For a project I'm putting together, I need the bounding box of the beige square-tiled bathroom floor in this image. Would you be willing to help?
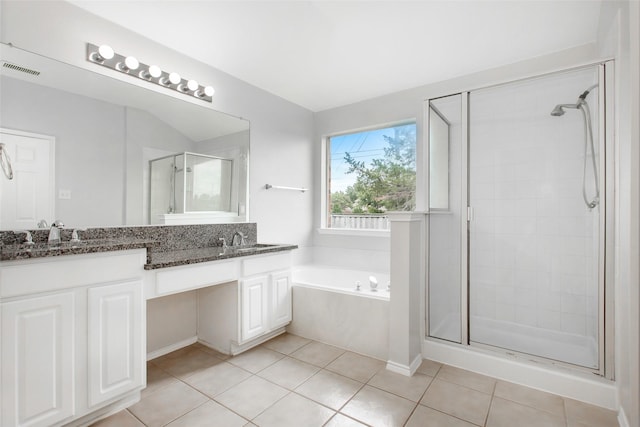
[94,334,618,427]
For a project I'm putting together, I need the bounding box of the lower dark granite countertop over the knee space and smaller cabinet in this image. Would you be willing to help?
[144,243,298,270]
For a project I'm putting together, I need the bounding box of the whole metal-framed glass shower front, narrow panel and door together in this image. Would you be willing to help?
[427,64,611,374]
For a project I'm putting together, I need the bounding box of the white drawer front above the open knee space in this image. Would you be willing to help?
[156,261,238,295]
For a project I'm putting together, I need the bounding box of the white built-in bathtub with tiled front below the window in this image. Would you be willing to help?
[287,265,391,361]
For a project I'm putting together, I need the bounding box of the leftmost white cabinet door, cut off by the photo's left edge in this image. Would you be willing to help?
[0,292,76,427]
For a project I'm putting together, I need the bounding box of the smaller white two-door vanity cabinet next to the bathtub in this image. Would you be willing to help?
[198,252,291,354]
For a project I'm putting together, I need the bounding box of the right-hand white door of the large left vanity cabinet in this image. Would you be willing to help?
[88,281,145,407]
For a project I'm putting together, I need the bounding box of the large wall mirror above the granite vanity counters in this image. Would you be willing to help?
[0,44,249,230]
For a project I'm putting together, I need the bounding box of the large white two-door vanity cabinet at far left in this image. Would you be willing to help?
[0,249,146,427]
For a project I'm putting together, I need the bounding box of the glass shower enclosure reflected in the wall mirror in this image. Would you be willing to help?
[149,152,233,224]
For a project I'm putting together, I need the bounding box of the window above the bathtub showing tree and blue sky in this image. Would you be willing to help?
[325,123,416,230]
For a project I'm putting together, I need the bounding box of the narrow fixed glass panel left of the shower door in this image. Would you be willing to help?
[428,94,467,343]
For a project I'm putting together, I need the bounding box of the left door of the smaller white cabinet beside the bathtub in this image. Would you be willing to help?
[240,276,269,342]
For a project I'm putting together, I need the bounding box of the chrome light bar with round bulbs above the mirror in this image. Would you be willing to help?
[87,43,214,102]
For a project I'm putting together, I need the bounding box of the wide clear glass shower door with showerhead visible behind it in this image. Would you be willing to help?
[468,66,605,370]
